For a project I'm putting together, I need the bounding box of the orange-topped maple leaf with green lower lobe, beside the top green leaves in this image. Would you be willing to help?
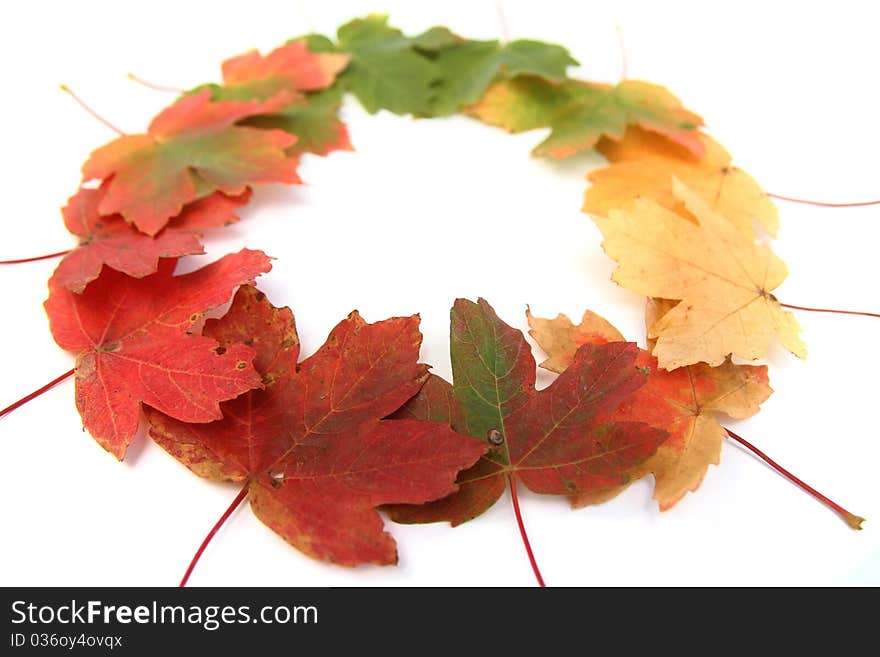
[197,39,352,155]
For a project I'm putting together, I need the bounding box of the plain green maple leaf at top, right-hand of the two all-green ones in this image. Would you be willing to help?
[431,39,578,116]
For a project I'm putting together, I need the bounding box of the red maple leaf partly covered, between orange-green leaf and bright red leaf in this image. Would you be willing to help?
[54,183,250,294]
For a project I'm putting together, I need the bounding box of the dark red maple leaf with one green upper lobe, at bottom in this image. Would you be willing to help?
[390,299,667,525]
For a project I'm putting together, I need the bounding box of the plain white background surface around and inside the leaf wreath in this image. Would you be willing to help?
[0,0,880,586]
